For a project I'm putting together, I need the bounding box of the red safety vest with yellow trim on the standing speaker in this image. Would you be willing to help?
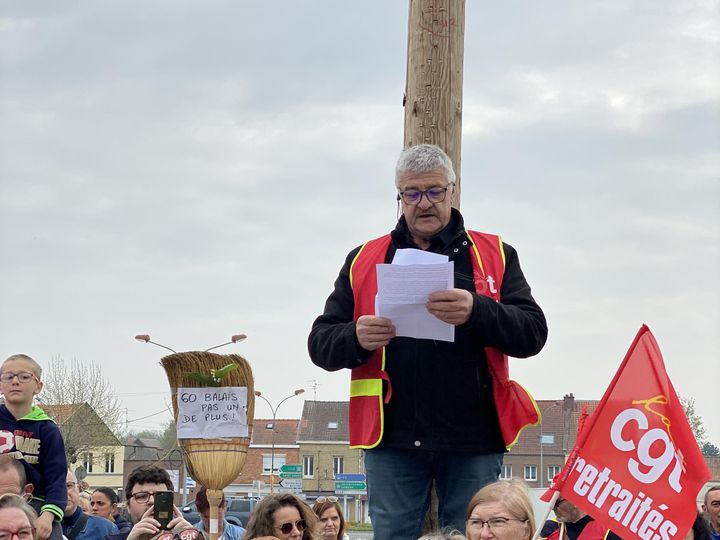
[349,231,540,450]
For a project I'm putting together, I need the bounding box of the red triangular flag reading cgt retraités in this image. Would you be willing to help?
[552,325,710,540]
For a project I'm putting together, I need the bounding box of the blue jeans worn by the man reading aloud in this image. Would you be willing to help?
[365,448,503,540]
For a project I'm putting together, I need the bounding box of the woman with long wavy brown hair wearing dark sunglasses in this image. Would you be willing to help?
[243,493,317,540]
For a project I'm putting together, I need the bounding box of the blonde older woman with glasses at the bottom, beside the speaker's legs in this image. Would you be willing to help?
[465,480,535,540]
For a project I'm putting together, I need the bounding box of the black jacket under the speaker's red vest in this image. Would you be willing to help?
[308,210,547,454]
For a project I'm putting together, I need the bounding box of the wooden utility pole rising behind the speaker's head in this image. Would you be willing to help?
[403,0,465,208]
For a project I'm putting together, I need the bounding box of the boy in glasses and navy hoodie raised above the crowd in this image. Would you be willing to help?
[0,354,67,540]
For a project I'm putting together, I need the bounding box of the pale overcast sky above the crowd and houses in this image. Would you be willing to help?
[0,0,720,445]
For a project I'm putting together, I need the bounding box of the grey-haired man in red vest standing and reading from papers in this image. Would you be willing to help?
[308,144,547,540]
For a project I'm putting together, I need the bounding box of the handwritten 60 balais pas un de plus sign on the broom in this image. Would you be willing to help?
[177,386,248,439]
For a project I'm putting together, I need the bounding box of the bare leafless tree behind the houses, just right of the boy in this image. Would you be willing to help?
[39,357,124,442]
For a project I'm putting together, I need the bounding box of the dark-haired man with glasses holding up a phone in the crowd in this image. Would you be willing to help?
[105,465,193,540]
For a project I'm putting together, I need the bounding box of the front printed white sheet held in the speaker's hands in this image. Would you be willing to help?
[375,260,455,341]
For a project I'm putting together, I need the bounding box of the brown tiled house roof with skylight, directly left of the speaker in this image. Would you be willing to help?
[298,401,349,442]
